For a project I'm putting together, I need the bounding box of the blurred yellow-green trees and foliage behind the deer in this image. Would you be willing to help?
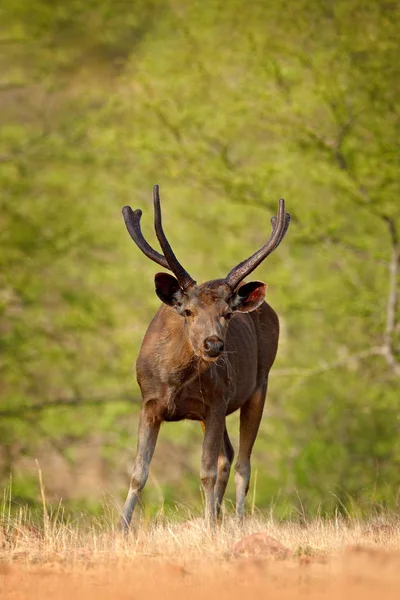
[0,0,400,517]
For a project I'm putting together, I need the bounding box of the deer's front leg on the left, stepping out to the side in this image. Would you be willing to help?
[118,405,161,533]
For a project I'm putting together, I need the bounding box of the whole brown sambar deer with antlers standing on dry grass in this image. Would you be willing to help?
[119,185,290,532]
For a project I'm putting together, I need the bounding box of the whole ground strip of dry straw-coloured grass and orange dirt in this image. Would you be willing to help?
[0,504,400,600]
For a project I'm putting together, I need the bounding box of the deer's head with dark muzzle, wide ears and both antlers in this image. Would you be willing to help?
[122,185,290,361]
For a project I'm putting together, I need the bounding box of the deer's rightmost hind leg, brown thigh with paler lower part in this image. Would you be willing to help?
[235,382,267,520]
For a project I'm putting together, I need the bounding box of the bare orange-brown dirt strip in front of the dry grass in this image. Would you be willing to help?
[0,547,400,600]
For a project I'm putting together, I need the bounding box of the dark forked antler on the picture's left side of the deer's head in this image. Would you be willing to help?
[122,185,196,291]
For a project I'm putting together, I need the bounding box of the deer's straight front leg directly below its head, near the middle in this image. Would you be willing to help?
[200,409,225,530]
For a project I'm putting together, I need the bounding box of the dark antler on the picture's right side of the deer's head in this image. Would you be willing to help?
[225,198,290,290]
